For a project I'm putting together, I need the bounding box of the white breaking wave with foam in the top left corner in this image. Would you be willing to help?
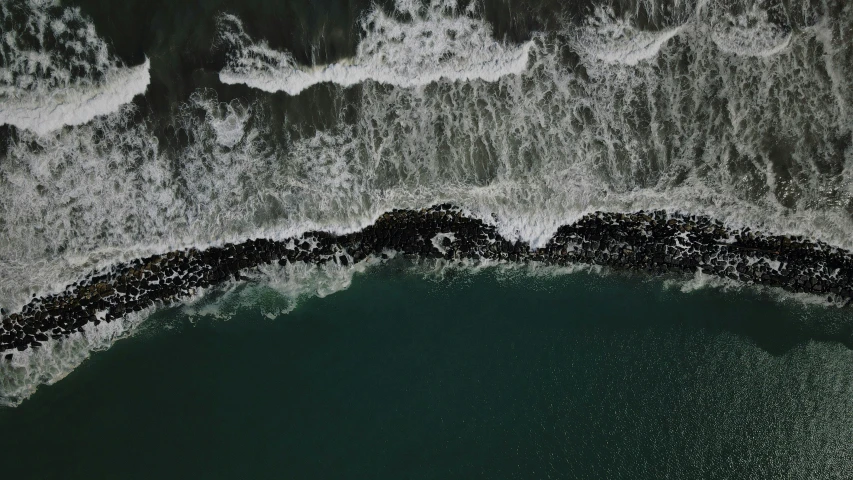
[0,0,150,135]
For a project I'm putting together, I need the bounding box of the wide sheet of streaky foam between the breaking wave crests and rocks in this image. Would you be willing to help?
[0,0,853,309]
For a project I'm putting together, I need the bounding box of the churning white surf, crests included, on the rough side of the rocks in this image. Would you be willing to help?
[0,0,853,404]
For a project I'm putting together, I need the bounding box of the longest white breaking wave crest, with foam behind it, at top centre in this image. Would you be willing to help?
[219,0,532,95]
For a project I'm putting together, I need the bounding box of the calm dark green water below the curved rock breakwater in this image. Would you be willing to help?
[0,266,853,479]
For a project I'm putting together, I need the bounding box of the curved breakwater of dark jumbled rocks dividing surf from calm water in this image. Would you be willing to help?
[0,204,853,360]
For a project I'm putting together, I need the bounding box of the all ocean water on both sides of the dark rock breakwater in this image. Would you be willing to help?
[0,0,853,472]
